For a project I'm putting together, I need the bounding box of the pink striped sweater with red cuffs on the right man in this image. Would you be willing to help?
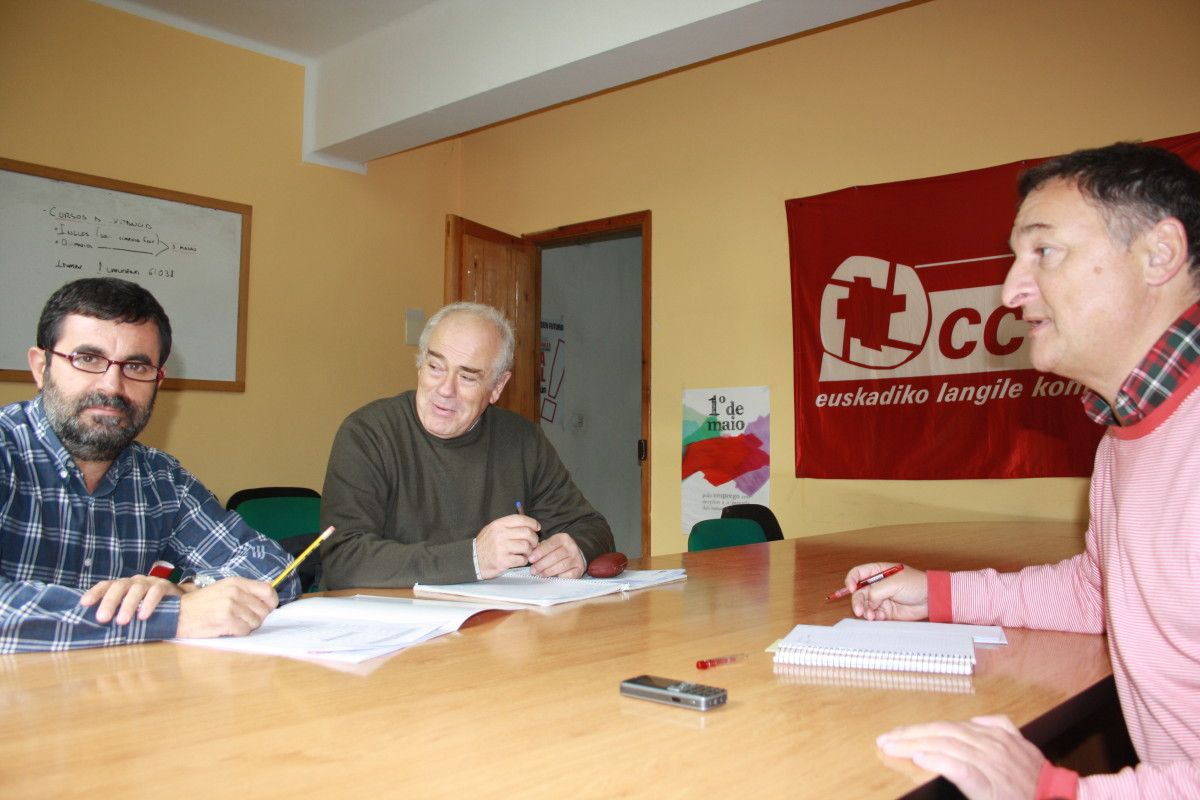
[930,369,1200,799]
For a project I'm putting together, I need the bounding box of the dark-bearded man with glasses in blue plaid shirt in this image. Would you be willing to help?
[0,278,299,652]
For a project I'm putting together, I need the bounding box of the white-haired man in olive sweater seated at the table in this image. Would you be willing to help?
[322,302,613,589]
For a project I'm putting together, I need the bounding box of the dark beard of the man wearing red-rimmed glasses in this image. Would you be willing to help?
[42,381,158,462]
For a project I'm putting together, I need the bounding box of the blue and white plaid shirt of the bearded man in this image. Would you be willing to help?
[0,396,300,652]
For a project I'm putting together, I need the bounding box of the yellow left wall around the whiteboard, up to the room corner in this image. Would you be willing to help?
[0,0,458,500]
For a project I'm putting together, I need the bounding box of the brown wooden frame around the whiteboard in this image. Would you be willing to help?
[0,157,251,392]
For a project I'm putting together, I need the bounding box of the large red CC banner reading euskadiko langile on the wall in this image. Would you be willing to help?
[785,134,1200,480]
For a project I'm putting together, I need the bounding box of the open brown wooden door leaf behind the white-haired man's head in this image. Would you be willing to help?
[444,213,541,422]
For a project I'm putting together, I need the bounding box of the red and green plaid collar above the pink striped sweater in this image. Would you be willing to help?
[1084,303,1200,427]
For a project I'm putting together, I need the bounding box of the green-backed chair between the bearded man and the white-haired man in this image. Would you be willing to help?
[226,486,320,591]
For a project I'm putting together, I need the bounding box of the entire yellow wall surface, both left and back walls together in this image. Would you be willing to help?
[0,0,1200,553]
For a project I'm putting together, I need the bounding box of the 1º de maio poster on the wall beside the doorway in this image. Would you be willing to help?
[683,386,770,534]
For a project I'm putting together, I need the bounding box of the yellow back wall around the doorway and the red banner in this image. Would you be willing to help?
[446,0,1200,553]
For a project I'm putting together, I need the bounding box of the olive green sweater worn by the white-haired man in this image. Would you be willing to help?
[320,391,613,589]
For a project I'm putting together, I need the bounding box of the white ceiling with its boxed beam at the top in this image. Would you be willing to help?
[94,0,901,172]
